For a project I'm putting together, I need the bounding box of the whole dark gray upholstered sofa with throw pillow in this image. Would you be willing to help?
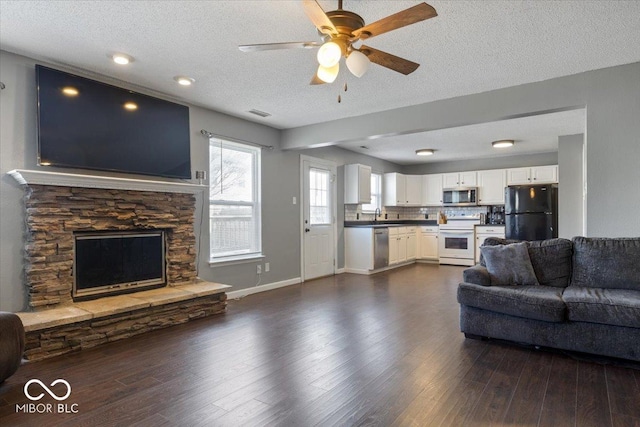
[458,237,640,361]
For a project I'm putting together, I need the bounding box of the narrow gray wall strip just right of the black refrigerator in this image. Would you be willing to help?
[558,134,584,239]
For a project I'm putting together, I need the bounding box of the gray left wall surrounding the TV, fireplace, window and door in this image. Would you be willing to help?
[0,51,399,311]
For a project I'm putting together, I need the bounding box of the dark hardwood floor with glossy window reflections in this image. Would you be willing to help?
[0,265,640,427]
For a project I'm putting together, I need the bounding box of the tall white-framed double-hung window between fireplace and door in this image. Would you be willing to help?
[209,138,262,261]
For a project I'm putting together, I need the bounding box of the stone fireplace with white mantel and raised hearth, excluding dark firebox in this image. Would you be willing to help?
[9,170,229,359]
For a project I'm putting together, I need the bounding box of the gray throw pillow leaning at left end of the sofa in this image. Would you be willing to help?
[480,242,539,285]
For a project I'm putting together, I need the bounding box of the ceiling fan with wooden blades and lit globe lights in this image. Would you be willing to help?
[238,0,438,84]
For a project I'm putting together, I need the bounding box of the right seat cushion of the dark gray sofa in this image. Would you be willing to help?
[562,286,640,328]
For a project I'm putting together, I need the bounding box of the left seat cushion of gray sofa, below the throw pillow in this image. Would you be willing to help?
[458,283,566,322]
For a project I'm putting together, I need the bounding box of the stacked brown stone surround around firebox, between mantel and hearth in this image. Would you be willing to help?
[25,185,196,309]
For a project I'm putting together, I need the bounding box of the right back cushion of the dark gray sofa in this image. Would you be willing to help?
[571,237,640,291]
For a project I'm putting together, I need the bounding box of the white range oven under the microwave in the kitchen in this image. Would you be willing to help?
[438,216,480,266]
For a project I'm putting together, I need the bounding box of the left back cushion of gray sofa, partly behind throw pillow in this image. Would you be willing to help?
[480,237,573,288]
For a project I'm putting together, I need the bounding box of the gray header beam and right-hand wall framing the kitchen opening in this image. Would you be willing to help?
[282,62,640,237]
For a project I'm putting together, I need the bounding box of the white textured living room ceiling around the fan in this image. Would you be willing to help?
[0,0,640,161]
